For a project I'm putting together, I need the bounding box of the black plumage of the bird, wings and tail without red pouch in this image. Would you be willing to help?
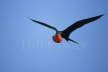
[31,15,103,44]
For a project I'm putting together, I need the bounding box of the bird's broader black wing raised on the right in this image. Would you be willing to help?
[63,15,103,38]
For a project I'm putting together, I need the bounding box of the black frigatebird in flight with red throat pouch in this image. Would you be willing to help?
[30,15,103,44]
